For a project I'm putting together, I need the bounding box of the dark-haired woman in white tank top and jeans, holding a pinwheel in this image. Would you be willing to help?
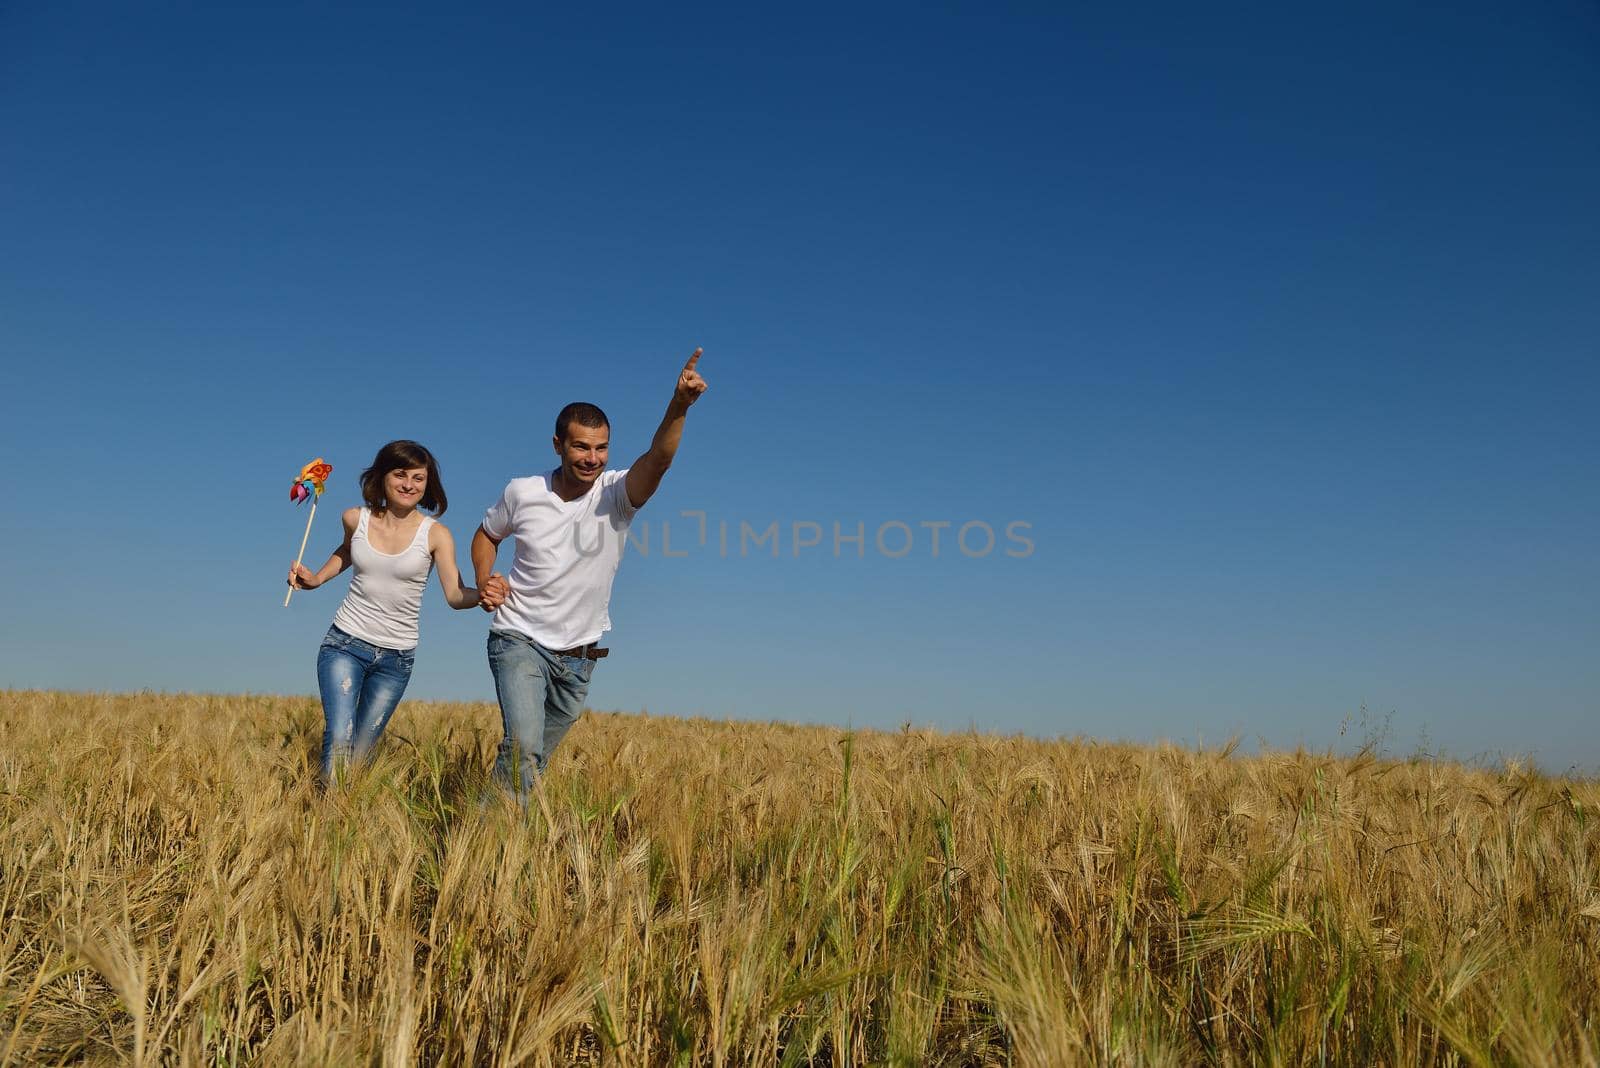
[290,441,478,780]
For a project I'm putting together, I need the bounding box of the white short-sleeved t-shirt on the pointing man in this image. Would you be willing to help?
[483,470,638,649]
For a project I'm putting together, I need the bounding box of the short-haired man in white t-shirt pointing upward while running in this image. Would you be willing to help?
[472,349,706,803]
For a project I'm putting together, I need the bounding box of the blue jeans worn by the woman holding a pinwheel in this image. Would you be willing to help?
[317,627,416,780]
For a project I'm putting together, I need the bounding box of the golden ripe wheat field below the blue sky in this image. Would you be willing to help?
[0,692,1600,1066]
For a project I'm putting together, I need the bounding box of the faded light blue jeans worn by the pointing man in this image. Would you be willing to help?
[490,630,595,804]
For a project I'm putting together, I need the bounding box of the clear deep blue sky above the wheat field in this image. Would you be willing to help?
[0,2,1600,771]
